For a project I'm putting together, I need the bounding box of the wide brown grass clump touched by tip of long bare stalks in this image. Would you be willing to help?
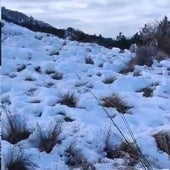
[101,94,131,113]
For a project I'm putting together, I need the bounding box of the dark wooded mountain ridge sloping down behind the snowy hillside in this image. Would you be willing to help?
[1,7,130,49]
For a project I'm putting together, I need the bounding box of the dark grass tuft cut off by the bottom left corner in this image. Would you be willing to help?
[2,148,35,170]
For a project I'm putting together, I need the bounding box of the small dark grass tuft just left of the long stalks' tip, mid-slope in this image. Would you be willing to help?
[58,93,77,107]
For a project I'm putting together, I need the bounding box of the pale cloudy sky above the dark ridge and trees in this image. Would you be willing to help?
[1,0,170,38]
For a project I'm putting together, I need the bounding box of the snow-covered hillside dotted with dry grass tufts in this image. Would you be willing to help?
[0,21,170,170]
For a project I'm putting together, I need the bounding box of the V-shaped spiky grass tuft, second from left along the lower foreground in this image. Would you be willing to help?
[36,122,62,153]
